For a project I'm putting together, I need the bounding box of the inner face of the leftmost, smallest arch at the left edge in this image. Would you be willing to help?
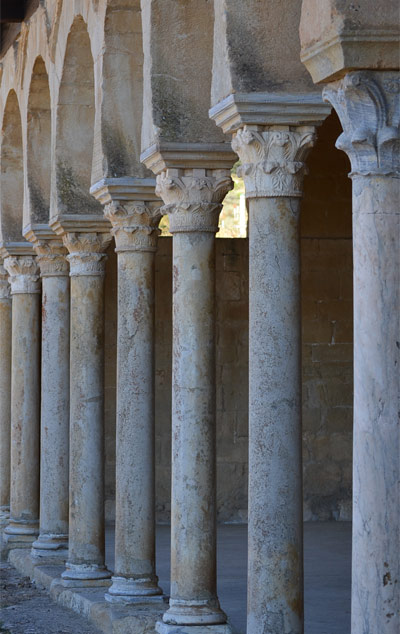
[0,89,24,245]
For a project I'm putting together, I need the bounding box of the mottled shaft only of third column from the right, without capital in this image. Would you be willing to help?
[171,233,217,604]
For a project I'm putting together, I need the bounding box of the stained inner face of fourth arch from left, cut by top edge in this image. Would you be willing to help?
[93,0,147,182]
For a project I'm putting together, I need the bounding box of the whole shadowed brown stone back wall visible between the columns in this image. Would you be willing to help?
[105,115,353,522]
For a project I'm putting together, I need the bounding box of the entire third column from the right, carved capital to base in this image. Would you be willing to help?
[156,169,231,634]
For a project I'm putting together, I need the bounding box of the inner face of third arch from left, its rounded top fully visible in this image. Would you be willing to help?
[52,16,102,215]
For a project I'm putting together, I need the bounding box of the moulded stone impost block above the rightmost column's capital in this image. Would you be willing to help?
[301,26,399,84]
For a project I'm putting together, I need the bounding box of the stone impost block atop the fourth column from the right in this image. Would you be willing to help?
[90,176,160,205]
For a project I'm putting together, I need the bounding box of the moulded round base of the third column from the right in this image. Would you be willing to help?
[163,599,226,627]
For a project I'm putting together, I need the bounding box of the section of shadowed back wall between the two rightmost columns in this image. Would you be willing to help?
[301,114,353,520]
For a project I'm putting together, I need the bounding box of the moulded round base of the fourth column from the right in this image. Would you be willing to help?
[104,577,164,603]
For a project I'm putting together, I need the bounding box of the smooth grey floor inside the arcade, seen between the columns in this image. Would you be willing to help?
[107,522,351,634]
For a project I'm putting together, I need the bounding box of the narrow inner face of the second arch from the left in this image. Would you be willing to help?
[27,56,51,223]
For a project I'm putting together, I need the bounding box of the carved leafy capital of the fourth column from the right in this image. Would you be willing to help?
[104,200,161,253]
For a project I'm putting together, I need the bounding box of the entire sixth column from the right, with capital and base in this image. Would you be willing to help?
[28,236,70,561]
